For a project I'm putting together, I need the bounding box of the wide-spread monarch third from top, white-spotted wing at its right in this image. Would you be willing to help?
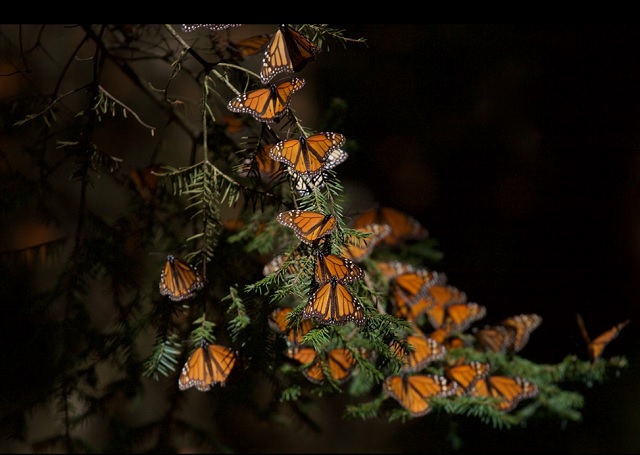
[269,132,348,176]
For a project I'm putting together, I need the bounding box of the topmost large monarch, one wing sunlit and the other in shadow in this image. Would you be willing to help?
[260,24,320,84]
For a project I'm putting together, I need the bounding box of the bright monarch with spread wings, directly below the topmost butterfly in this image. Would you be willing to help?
[227,77,305,123]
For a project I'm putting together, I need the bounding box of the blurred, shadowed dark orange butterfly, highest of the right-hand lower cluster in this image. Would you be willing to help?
[352,207,429,245]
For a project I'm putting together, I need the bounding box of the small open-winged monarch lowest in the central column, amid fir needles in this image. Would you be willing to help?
[294,348,356,384]
